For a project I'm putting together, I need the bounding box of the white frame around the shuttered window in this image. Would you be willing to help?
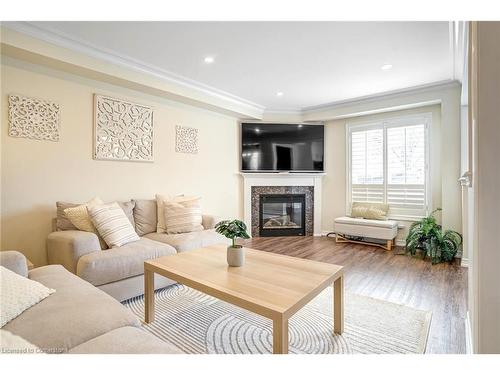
[345,112,432,221]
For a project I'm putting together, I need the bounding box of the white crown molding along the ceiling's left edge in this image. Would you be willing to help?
[2,21,265,119]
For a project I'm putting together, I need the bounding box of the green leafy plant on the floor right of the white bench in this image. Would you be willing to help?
[406,208,462,264]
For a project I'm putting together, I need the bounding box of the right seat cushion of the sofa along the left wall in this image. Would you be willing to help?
[144,229,227,252]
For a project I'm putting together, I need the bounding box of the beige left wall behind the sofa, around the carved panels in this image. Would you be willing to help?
[1,59,242,265]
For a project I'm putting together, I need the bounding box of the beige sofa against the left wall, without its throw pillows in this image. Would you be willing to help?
[47,199,226,301]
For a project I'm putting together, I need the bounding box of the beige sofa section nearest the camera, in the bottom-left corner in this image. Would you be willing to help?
[0,251,181,354]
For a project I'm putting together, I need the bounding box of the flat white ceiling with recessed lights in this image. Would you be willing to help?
[18,22,453,111]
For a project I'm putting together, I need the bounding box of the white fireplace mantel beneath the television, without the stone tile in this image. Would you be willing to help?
[240,172,325,236]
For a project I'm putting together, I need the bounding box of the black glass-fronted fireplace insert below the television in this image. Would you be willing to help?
[259,194,306,237]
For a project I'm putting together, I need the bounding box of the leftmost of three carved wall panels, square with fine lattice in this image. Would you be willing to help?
[9,94,59,141]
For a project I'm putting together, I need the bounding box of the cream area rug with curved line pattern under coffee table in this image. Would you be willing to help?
[124,284,431,354]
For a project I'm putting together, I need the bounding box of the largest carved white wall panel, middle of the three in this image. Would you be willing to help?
[94,94,154,162]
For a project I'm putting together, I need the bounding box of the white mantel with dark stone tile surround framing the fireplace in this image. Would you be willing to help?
[241,173,324,236]
